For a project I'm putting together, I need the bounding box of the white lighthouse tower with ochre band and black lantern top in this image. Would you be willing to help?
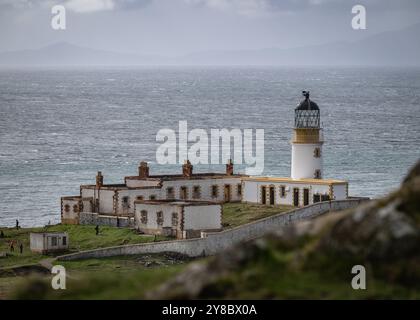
[291,91,323,179]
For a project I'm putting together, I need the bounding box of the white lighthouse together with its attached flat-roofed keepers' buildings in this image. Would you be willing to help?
[61,91,348,238]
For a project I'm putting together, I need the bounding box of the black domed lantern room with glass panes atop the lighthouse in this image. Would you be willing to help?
[295,91,321,129]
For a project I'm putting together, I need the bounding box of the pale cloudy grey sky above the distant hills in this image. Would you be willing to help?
[0,0,420,56]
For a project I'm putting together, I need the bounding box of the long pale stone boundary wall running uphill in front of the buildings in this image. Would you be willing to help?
[57,199,366,260]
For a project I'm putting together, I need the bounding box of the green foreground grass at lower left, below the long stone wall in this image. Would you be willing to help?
[8,255,187,299]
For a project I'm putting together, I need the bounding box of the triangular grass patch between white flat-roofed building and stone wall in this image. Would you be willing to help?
[222,203,294,228]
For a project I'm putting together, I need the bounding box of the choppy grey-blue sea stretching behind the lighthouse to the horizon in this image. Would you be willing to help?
[0,67,420,226]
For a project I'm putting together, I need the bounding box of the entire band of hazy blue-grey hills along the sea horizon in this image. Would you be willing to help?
[0,23,420,66]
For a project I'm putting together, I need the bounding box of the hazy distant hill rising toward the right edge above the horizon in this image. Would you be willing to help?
[182,23,420,66]
